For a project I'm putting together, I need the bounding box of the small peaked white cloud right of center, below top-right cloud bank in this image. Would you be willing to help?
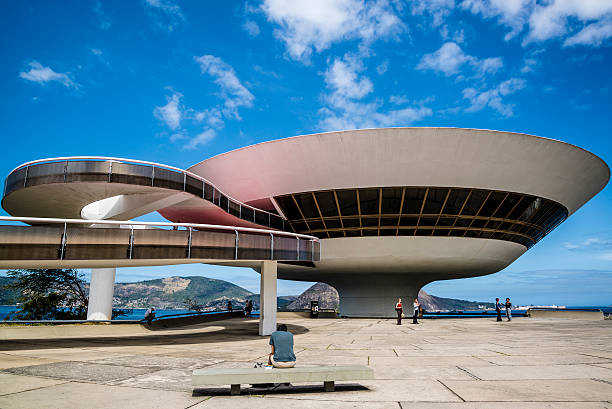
[417,42,504,77]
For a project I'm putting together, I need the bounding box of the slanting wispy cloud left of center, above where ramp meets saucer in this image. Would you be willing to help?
[194,55,255,119]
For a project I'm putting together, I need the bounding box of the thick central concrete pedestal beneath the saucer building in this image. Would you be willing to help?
[326,274,426,318]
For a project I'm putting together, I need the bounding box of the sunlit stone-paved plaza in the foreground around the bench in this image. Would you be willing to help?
[0,318,612,409]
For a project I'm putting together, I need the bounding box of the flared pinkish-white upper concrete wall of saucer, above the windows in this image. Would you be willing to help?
[189,128,610,214]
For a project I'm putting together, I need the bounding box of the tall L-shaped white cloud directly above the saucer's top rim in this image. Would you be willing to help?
[319,54,432,131]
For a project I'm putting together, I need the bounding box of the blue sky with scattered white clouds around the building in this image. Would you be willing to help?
[0,0,612,305]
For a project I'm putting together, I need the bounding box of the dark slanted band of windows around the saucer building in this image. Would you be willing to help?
[275,187,568,248]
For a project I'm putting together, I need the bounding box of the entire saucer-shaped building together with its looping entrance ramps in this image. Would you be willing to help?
[0,128,610,317]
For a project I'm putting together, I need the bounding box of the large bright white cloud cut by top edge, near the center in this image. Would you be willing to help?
[261,0,404,62]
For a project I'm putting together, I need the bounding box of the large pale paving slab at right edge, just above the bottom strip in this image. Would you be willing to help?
[444,379,612,402]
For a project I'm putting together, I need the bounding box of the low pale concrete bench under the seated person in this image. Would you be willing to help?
[191,365,374,395]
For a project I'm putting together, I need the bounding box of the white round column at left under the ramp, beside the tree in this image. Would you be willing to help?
[87,268,116,321]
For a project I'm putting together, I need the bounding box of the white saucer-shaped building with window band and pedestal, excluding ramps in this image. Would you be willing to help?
[185,128,610,317]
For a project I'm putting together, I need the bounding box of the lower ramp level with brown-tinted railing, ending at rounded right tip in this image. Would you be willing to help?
[0,217,320,268]
